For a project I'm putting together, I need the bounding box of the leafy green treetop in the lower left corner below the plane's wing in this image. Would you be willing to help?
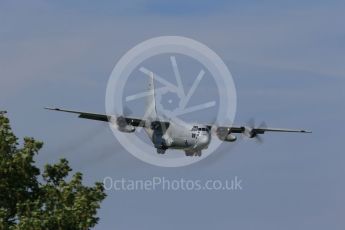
[0,112,106,229]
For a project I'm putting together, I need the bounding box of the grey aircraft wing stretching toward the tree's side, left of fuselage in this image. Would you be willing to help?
[45,107,145,127]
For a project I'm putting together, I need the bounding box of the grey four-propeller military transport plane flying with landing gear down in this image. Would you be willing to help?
[45,73,311,156]
